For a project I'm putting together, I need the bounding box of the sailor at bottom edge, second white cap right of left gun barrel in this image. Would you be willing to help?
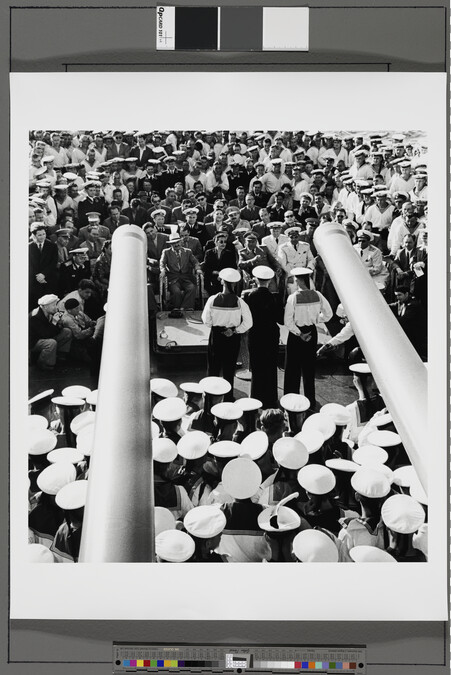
[183,504,227,562]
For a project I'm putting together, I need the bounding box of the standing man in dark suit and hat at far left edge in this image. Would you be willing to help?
[28,227,58,309]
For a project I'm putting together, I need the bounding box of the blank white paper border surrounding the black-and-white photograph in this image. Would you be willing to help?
[10,72,449,621]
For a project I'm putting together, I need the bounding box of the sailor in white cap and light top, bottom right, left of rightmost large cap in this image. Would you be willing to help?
[338,467,391,562]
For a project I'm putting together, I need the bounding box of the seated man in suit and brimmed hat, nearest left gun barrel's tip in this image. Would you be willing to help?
[160,234,201,318]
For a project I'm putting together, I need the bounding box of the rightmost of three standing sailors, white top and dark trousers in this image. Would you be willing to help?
[284,267,332,409]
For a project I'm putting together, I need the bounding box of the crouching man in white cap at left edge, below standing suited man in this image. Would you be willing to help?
[28,293,72,370]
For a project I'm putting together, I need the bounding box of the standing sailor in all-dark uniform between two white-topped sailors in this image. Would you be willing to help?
[241,266,283,409]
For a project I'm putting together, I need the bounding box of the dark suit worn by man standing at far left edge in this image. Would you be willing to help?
[28,239,58,309]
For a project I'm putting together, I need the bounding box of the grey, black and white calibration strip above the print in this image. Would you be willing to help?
[156,5,309,52]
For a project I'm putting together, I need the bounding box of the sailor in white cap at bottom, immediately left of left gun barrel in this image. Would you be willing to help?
[50,480,88,563]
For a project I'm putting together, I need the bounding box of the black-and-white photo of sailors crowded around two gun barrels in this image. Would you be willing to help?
[24,125,432,573]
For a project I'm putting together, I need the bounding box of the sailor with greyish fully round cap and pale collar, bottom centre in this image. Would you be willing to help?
[216,457,271,562]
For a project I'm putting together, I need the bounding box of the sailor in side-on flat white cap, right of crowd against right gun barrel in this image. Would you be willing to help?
[346,363,385,443]
